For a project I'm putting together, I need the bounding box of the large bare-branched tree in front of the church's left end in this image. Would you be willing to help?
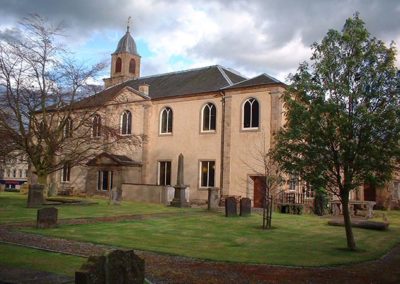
[0,15,140,190]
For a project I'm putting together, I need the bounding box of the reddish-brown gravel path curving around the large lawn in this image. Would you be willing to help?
[0,214,400,284]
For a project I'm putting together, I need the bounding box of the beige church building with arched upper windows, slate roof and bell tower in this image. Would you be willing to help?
[56,27,295,206]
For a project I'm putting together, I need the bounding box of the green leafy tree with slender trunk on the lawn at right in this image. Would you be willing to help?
[274,13,400,250]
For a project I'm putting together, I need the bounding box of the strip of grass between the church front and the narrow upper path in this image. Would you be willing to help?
[0,192,182,224]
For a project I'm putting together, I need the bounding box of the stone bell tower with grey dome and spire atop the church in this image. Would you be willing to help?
[103,17,140,88]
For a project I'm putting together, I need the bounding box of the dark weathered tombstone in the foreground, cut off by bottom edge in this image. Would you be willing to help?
[75,250,144,284]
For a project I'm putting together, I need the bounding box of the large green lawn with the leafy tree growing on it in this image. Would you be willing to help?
[23,211,400,266]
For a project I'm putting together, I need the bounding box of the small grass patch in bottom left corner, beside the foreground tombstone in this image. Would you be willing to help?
[0,244,86,276]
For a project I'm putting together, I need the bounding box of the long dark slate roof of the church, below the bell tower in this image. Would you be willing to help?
[70,65,247,108]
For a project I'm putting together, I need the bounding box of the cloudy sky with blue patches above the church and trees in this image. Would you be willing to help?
[0,0,400,81]
